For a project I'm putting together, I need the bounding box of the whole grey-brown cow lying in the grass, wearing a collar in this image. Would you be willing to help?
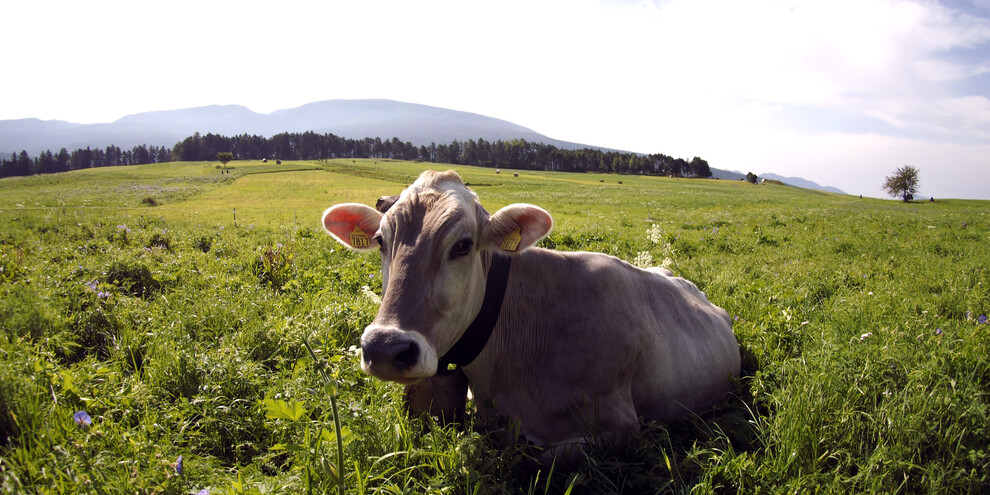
[323,171,740,458]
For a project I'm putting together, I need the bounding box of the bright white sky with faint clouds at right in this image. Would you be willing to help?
[0,0,990,199]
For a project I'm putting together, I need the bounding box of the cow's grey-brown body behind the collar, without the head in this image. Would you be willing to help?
[465,249,739,442]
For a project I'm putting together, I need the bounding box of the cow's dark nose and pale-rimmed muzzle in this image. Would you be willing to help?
[361,326,437,383]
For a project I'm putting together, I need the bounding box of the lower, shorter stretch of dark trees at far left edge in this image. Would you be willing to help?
[0,144,172,177]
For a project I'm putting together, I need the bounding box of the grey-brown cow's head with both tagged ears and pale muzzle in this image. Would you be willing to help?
[323,171,553,383]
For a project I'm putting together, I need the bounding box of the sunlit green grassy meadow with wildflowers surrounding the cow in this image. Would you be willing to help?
[0,160,990,494]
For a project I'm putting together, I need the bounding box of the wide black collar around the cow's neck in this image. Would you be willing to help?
[437,253,512,373]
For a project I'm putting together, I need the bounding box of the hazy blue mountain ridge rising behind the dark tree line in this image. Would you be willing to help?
[0,100,592,156]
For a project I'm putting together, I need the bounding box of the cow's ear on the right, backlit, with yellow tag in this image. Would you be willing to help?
[485,204,553,254]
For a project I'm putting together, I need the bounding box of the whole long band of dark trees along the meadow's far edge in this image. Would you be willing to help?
[0,132,712,178]
